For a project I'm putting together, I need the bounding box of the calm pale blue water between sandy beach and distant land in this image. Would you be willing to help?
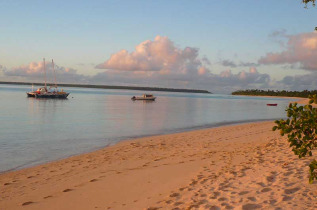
[0,85,291,172]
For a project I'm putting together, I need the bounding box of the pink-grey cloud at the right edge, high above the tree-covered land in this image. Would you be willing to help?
[259,32,317,70]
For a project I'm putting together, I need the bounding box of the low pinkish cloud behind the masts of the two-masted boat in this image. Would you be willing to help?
[3,62,89,83]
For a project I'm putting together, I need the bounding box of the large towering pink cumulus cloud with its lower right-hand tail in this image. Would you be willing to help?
[94,36,270,92]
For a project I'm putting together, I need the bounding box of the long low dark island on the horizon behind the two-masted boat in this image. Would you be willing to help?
[0,81,211,94]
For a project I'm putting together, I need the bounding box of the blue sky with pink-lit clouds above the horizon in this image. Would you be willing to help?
[0,0,317,93]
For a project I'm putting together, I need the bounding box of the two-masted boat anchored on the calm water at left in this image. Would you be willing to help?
[26,58,69,99]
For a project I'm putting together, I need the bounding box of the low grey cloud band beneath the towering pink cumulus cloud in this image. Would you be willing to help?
[91,67,271,93]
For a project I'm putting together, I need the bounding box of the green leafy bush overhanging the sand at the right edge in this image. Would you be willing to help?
[273,95,317,183]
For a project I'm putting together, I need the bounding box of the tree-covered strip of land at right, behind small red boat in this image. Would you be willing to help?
[231,89,317,98]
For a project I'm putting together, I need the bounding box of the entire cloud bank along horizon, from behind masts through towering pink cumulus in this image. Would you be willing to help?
[4,36,270,93]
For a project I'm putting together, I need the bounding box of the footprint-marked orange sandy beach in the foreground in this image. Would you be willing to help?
[0,122,317,209]
